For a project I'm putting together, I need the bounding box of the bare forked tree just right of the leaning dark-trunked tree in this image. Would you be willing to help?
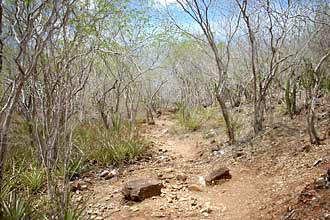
[236,0,293,134]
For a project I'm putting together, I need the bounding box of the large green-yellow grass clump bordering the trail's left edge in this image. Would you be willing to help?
[76,121,146,165]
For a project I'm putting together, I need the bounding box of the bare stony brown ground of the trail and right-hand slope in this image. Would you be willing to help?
[72,102,330,220]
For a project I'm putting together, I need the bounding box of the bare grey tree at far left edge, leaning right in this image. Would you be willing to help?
[0,0,63,185]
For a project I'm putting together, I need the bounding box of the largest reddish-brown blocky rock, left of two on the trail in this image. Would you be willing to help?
[122,179,163,201]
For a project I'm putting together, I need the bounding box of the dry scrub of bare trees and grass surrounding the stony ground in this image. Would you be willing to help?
[0,0,330,220]
